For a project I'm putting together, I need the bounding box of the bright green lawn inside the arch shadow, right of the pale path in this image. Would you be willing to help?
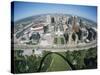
[47,54,71,71]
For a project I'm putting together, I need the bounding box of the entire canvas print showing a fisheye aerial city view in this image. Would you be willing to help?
[11,2,97,73]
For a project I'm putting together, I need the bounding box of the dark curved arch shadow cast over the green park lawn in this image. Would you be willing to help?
[37,52,76,72]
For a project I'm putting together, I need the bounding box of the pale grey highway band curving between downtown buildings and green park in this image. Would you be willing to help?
[14,40,97,52]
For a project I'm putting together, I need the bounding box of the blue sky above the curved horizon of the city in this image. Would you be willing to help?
[11,2,97,22]
